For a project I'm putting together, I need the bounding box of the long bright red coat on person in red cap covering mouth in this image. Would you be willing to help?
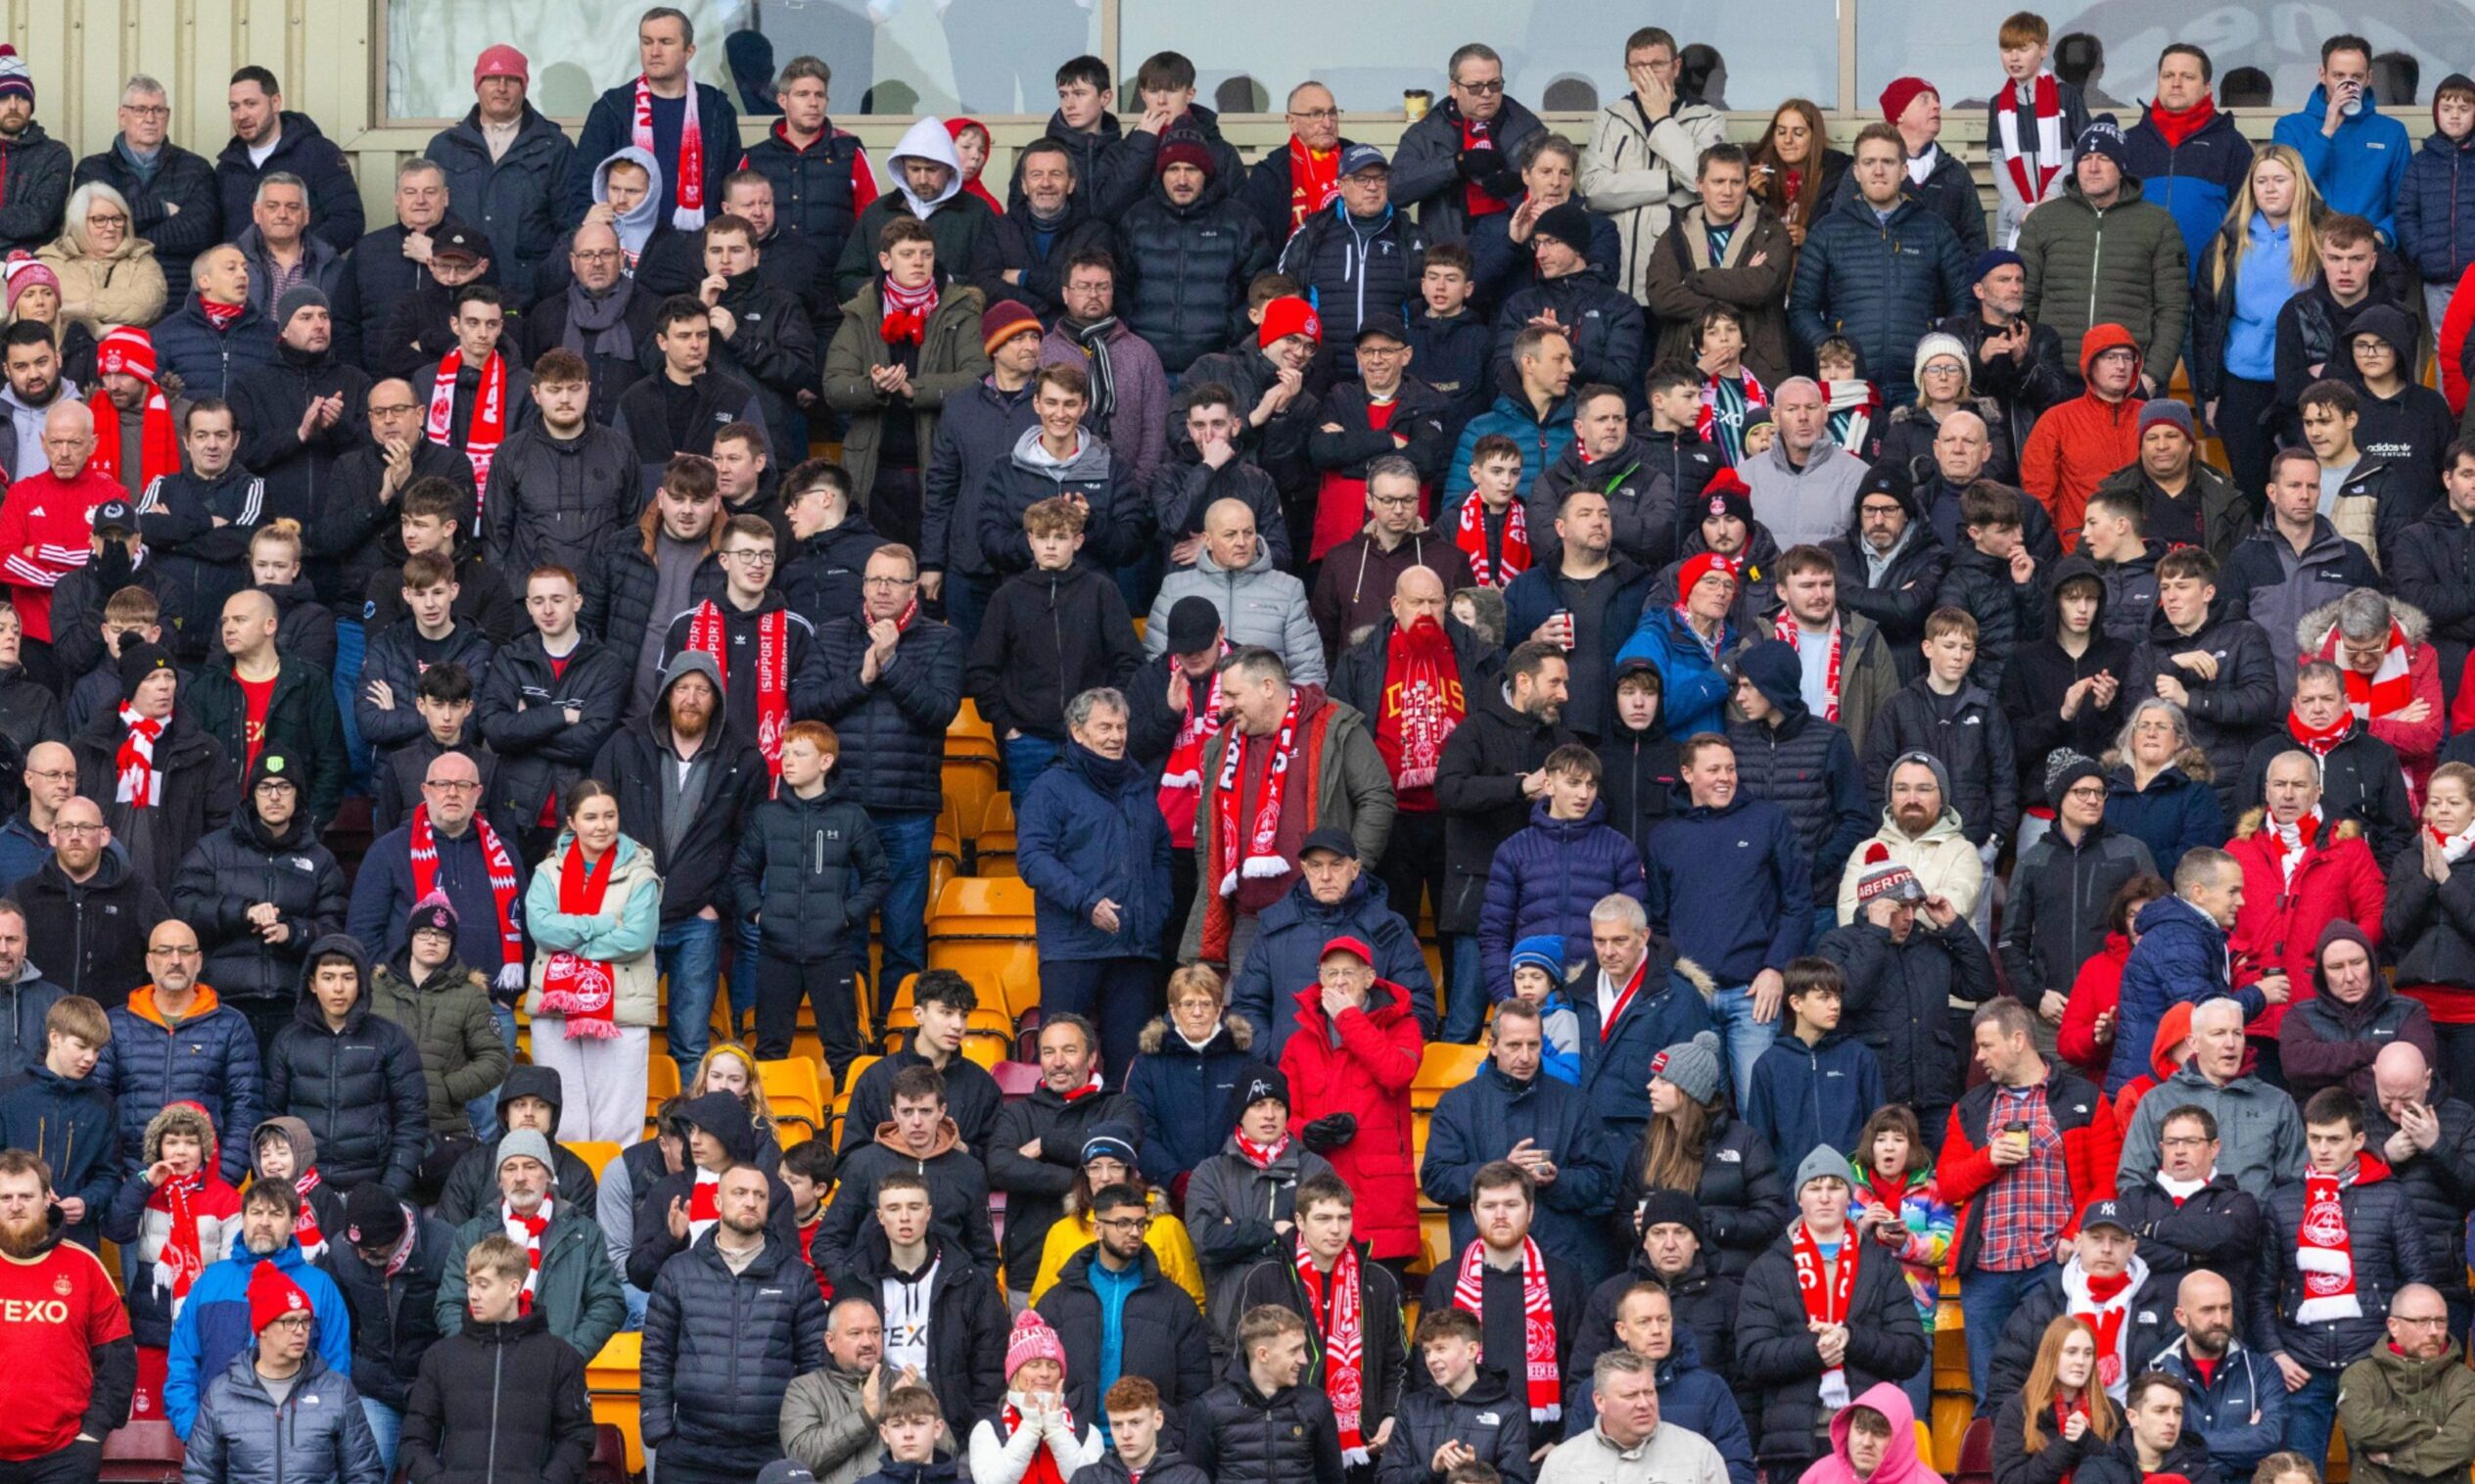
[1280,980,1425,1259]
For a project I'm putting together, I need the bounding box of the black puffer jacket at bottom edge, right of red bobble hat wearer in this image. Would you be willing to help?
[401,1311,594,1484]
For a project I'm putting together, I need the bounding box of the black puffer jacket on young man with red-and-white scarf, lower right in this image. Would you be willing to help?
[2252,1147,2460,1370]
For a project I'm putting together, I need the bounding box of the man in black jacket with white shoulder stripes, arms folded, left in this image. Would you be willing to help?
[132,398,265,680]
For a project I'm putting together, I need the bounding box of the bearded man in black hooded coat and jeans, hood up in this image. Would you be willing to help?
[591,651,772,1076]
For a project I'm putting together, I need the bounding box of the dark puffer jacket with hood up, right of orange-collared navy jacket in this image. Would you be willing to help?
[267,933,431,1197]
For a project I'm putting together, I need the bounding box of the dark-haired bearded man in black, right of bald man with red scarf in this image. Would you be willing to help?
[1411,637,1564,1046]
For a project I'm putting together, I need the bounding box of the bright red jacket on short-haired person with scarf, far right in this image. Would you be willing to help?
[2225,812,2389,1037]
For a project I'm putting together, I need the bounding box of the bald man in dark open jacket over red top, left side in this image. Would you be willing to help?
[186,588,347,823]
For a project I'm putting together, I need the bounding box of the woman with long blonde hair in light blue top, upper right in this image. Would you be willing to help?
[2190,144,2326,497]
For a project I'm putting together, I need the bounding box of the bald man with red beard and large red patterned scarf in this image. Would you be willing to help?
[1324,551,1502,945]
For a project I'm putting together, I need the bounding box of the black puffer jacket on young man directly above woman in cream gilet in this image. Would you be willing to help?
[478,630,631,821]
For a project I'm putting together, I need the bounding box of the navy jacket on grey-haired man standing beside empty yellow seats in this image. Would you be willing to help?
[1014,742,1178,964]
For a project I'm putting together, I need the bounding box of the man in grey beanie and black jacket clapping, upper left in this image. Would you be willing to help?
[233,295,369,561]
